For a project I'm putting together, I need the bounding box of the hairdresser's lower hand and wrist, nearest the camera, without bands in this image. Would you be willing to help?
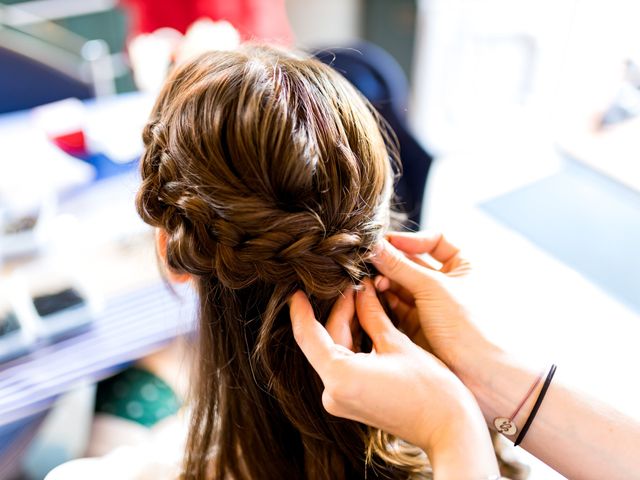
[290,280,497,478]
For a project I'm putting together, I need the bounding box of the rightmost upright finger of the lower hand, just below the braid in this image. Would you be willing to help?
[356,278,399,352]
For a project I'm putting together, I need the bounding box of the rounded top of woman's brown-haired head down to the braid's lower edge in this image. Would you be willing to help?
[138,47,391,298]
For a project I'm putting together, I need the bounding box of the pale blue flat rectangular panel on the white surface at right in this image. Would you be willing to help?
[480,159,640,312]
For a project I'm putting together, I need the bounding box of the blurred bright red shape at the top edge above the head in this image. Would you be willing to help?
[123,0,293,45]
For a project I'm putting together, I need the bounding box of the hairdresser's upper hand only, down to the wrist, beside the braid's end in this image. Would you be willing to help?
[372,232,494,374]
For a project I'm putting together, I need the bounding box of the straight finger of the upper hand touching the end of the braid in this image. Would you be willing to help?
[371,240,437,295]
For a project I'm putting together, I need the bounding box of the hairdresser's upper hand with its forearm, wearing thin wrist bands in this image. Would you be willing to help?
[373,232,640,480]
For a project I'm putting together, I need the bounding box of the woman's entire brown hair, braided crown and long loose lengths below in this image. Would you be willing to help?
[137,46,424,479]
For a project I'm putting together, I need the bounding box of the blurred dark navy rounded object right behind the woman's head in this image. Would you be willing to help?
[314,42,432,230]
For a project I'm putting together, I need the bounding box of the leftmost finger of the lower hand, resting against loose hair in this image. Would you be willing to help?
[289,290,335,378]
